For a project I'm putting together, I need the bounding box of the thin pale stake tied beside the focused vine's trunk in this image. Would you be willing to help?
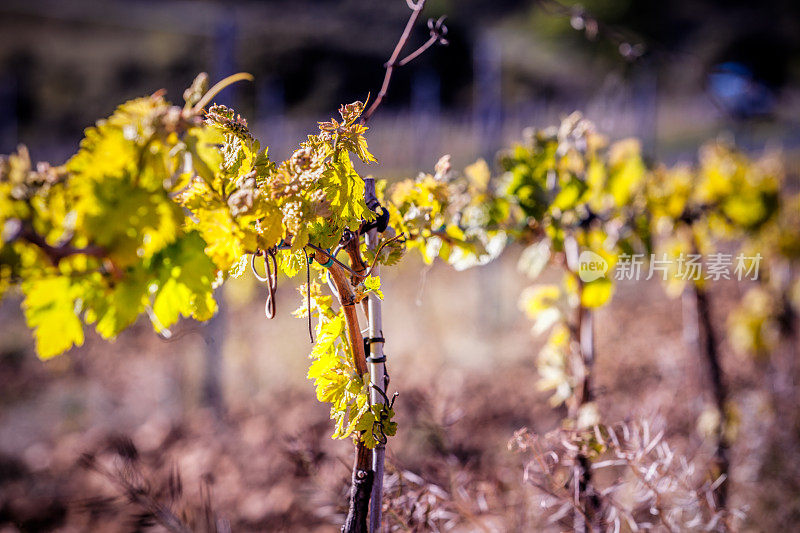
[364,178,388,533]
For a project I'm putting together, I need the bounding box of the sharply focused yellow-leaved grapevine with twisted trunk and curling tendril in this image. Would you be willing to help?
[0,5,468,531]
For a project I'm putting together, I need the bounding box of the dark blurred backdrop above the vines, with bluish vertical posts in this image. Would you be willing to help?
[0,0,800,171]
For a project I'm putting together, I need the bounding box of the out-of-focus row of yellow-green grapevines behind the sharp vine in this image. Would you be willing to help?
[393,114,800,528]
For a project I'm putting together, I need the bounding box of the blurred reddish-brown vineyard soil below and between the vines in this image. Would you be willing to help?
[0,254,798,532]
